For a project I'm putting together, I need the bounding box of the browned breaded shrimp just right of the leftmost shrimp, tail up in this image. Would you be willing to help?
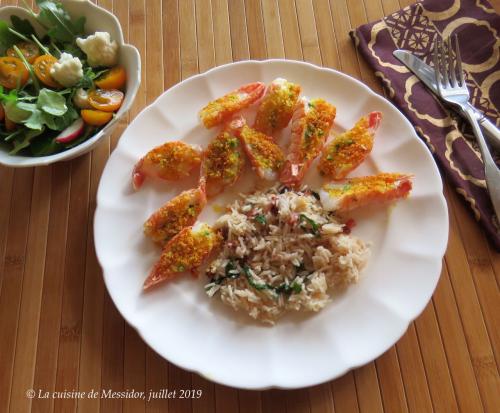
[201,118,245,198]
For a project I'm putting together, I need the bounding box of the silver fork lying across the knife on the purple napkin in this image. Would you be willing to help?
[434,36,500,220]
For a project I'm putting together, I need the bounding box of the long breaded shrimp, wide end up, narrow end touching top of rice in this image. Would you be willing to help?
[280,97,336,186]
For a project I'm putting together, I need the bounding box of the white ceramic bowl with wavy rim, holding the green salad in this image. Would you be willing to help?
[0,0,141,168]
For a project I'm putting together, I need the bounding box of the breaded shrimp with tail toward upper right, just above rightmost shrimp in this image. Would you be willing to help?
[318,112,382,180]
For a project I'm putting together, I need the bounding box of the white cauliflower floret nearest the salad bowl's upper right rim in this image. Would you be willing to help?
[76,32,118,67]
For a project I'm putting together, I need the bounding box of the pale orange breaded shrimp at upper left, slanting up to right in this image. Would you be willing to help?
[199,82,266,128]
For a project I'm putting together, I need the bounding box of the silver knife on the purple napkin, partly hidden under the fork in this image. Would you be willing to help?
[393,50,500,150]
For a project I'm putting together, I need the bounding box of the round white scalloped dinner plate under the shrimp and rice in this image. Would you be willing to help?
[94,60,448,389]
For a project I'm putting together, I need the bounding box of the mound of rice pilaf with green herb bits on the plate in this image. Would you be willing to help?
[205,186,370,324]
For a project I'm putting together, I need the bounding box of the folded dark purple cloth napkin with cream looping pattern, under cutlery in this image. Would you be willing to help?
[351,0,500,251]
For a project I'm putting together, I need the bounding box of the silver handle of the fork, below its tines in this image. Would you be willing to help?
[465,108,500,219]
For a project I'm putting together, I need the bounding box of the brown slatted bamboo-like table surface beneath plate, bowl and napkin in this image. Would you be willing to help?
[0,0,500,413]
